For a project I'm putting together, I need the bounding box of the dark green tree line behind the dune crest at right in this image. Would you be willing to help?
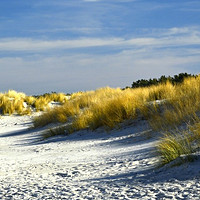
[126,73,197,88]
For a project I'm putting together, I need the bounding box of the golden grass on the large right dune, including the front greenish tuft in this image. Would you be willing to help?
[34,76,200,164]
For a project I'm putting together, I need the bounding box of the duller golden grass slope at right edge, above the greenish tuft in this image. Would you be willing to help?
[150,76,200,130]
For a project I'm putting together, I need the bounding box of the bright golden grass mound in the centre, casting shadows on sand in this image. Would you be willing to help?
[37,87,148,130]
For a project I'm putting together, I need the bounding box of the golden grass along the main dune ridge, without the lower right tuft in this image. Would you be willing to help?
[36,76,200,133]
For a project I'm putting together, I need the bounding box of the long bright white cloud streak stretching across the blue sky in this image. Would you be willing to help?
[0,27,200,51]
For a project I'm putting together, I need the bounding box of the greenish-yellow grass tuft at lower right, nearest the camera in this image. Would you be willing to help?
[157,116,200,164]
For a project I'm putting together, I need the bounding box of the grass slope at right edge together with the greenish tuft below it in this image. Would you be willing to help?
[149,76,200,164]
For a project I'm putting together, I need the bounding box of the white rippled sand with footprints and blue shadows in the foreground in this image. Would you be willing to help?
[0,116,200,200]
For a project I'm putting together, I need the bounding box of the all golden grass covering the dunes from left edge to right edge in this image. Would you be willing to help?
[0,74,200,164]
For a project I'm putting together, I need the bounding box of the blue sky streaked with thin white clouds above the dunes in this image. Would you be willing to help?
[0,0,200,95]
